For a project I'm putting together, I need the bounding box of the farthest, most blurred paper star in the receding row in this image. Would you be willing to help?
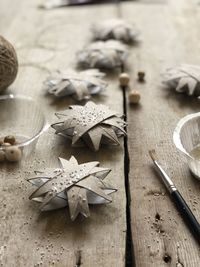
[92,19,138,43]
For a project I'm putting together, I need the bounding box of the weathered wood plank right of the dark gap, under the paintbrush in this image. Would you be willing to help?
[122,1,200,267]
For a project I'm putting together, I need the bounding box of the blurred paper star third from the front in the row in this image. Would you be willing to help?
[44,69,107,101]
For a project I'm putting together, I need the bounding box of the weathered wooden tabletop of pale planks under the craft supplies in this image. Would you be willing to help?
[0,0,200,267]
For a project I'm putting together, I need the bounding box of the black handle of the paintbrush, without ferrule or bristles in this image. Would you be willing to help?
[171,190,200,244]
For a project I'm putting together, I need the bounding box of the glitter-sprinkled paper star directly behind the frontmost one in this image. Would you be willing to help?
[51,101,125,151]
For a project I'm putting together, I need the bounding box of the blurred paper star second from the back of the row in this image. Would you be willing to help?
[77,40,127,69]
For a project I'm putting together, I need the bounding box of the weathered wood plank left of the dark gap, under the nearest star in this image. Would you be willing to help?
[0,1,126,267]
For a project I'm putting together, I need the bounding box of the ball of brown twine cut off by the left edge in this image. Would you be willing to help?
[0,35,18,92]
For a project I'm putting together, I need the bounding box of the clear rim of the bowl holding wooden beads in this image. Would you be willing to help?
[0,94,50,150]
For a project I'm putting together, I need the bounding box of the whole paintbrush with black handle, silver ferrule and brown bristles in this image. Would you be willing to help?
[149,149,200,244]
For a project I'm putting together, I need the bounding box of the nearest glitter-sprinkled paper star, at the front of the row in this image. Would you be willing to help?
[28,156,116,220]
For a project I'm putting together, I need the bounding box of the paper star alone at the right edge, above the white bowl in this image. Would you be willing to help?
[163,64,200,96]
